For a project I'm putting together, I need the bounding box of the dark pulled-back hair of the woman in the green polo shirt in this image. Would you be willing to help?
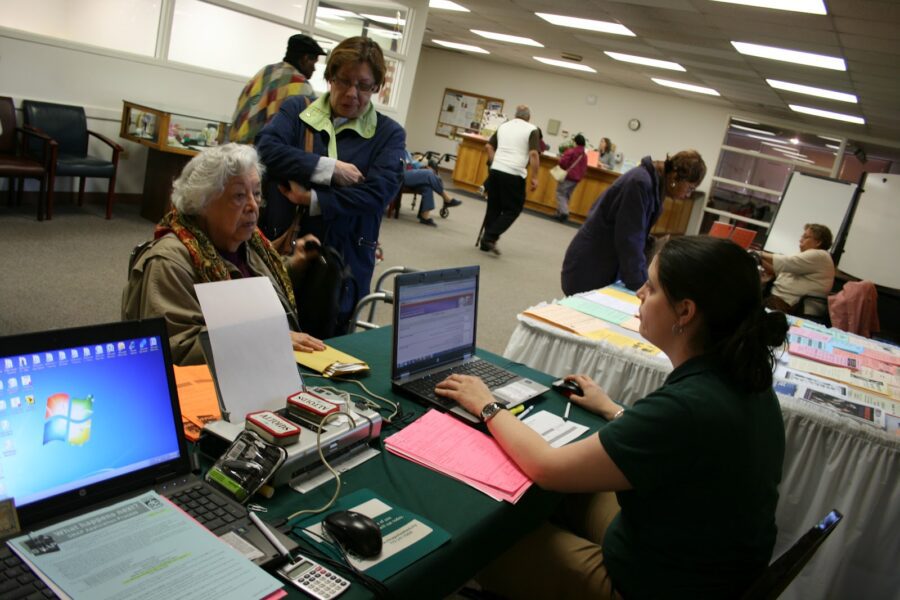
[657,236,788,391]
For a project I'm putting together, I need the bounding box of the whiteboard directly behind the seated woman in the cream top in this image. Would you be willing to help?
[763,171,856,258]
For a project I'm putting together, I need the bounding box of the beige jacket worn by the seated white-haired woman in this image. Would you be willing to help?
[122,233,300,365]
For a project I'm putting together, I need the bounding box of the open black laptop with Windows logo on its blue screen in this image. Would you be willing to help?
[0,319,296,593]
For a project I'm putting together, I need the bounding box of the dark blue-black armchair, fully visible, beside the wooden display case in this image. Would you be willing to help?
[22,100,122,219]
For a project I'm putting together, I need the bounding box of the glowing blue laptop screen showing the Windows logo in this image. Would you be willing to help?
[0,321,184,524]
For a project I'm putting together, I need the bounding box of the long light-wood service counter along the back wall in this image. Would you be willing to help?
[453,135,693,235]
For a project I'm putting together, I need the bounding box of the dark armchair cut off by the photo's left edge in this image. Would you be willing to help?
[0,96,54,221]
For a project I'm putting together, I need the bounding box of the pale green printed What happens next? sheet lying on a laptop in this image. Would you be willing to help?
[9,491,282,600]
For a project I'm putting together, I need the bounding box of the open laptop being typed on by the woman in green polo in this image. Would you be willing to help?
[391,265,549,423]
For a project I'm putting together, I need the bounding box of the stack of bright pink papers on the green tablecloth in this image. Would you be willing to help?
[384,409,532,504]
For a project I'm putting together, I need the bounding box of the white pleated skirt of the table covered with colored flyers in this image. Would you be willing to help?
[503,315,900,600]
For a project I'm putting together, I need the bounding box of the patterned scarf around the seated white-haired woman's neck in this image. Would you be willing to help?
[153,207,297,312]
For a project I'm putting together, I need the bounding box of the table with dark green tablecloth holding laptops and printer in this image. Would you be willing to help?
[256,327,605,600]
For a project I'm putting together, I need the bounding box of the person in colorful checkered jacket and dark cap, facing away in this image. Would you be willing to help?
[229,33,326,144]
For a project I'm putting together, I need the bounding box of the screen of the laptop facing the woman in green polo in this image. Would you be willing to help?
[393,266,478,379]
